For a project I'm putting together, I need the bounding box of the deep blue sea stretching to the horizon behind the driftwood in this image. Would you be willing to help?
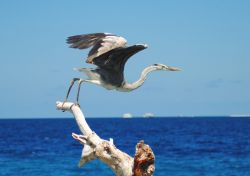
[0,117,250,176]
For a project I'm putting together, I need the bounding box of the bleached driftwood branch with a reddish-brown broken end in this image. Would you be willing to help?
[56,102,155,176]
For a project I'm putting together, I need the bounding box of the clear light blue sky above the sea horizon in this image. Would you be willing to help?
[0,0,250,118]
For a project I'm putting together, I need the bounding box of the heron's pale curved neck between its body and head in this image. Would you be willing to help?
[123,65,158,92]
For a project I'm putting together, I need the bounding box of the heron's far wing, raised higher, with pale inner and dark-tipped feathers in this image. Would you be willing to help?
[67,33,127,63]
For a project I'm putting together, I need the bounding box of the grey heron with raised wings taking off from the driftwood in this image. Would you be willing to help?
[65,33,180,104]
